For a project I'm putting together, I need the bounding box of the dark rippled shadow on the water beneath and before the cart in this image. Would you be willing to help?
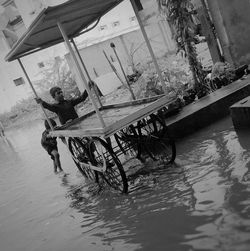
[57,164,217,250]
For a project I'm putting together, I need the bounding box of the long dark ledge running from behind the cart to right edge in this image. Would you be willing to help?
[166,76,250,139]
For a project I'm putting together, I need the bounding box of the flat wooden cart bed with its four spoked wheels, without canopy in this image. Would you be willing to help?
[51,96,176,193]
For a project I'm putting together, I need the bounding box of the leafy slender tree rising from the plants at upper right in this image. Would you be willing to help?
[156,0,206,97]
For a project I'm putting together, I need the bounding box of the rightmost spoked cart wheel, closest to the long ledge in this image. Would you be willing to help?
[137,114,176,164]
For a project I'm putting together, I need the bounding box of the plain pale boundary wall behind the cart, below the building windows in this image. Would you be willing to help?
[71,24,175,78]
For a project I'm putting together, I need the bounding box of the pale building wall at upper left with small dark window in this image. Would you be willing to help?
[0,0,69,113]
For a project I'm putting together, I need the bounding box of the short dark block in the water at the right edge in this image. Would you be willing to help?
[230,96,250,129]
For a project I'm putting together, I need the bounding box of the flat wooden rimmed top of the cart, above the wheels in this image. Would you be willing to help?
[51,95,175,138]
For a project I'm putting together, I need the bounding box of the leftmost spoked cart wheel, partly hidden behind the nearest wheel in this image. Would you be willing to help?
[68,138,98,183]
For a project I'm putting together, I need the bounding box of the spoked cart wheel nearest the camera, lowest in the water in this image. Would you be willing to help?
[89,138,128,193]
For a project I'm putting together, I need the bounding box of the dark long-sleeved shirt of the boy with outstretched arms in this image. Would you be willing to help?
[42,91,88,125]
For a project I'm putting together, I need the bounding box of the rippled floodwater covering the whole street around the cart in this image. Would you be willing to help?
[0,118,250,251]
